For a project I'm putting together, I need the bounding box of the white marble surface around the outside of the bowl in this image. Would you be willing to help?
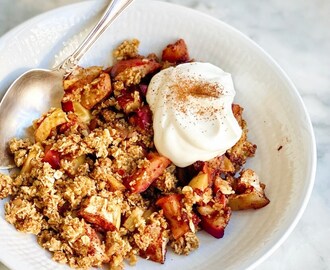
[0,0,330,270]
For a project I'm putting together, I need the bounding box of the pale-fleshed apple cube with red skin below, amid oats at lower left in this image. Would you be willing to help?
[78,196,121,231]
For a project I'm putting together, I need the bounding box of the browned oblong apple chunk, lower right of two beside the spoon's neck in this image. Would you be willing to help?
[80,72,111,110]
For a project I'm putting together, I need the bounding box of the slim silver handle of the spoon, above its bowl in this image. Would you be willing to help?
[54,0,134,76]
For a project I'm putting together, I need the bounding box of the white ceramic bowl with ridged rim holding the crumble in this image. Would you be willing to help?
[0,0,316,270]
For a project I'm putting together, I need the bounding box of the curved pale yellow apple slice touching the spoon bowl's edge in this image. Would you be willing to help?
[34,108,68,142]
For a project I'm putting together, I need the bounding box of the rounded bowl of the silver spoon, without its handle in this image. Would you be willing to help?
[0,69,64,169]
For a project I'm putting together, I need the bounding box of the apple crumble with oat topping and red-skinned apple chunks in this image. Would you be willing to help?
[0,39,269,269]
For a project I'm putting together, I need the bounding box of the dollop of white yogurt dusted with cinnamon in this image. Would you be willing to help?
[147,62,242,167]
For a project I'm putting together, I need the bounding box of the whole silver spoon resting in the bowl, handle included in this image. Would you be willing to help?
[0,0,134,169]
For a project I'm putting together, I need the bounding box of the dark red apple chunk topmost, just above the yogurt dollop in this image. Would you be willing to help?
[162,39,189,63]
